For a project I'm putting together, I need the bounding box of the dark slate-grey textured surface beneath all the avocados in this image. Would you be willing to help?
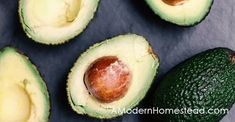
[0,0,235,122]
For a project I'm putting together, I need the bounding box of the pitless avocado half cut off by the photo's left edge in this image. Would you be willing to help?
[0,47,50,122]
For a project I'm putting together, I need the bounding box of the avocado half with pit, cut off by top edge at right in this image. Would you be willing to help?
[145,0,213,26]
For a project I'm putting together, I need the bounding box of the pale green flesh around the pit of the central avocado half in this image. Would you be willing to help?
[67,34,159,119]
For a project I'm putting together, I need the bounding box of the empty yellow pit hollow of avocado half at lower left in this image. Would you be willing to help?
[0,85,31,122]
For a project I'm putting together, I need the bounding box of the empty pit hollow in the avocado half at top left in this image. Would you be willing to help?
[32,0,81,27]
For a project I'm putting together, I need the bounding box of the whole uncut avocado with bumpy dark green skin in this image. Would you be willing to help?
[153,48,235,122]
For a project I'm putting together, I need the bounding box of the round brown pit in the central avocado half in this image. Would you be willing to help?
[84,56,131,103]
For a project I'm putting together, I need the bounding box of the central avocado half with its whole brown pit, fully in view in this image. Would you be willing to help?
[67,34,159,119]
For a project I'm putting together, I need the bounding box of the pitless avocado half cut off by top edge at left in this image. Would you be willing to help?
[19,0,99,44]
